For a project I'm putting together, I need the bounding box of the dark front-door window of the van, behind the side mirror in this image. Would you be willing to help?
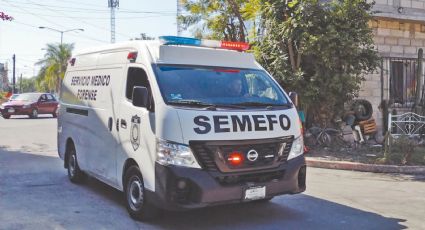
[125,67,154,110]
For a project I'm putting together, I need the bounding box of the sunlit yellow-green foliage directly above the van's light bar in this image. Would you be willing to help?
[178,0,260,42]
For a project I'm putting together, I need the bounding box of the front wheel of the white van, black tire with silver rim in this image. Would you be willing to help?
[124,165,159,220]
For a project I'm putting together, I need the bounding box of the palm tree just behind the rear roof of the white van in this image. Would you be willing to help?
[37,44,74,94]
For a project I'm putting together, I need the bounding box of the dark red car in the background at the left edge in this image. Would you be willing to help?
[0,93,59,119]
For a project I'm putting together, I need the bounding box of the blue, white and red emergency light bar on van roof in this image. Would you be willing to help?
[159,36,249,51]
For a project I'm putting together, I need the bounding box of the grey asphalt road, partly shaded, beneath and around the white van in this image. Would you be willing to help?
[0,116,425,230]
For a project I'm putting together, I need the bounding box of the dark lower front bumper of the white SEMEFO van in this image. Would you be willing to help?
[146,156,306,210]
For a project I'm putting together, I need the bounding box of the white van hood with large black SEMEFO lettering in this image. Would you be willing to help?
[171,108,301,144]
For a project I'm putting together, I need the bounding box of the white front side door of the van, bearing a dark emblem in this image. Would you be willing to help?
[117,65,155,191]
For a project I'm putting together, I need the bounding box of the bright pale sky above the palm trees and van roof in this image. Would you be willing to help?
[0,0,177,79]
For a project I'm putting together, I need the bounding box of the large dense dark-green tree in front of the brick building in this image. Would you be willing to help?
[254,0,379,126]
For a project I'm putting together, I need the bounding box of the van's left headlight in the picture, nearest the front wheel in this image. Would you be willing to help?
[156,139,201,168]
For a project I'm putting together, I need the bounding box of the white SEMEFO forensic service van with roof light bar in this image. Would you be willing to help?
[58,36,306,219]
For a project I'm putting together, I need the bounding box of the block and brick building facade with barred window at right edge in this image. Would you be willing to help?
[359,0,425,134]
